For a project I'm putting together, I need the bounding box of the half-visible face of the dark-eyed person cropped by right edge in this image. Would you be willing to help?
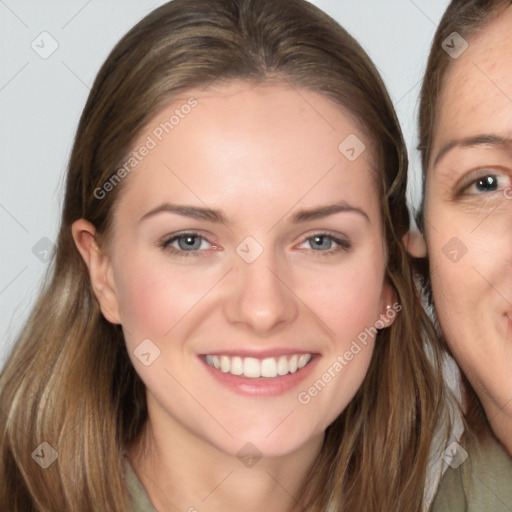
[425,8,512,450]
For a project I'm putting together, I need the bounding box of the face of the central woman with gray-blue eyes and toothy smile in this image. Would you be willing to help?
[92,83,393,456]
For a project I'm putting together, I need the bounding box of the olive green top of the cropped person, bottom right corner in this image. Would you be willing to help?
[432,436,512,512]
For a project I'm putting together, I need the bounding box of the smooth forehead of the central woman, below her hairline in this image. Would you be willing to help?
[116,83,377,220]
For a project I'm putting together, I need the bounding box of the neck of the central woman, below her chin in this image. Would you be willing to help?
[127,400,323,512]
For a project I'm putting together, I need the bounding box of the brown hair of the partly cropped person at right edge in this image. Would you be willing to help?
[415,0,511,436]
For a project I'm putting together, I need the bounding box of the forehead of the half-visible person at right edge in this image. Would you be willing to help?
[434,7,512,146]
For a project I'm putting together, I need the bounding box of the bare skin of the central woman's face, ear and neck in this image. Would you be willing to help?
[73,82,394,511]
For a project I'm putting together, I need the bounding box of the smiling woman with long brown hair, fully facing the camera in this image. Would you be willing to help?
[0,0,447,512]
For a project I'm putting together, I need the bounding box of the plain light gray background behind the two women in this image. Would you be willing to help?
[0,0,449,364]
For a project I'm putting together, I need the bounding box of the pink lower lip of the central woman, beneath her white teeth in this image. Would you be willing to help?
[200,355,320,396]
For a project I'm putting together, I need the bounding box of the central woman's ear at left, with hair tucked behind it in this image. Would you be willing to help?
[71,219,121,324]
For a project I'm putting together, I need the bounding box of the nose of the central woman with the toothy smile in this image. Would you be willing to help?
[224,252,299,336]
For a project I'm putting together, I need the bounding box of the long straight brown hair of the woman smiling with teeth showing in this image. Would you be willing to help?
[0,0,446,512]
